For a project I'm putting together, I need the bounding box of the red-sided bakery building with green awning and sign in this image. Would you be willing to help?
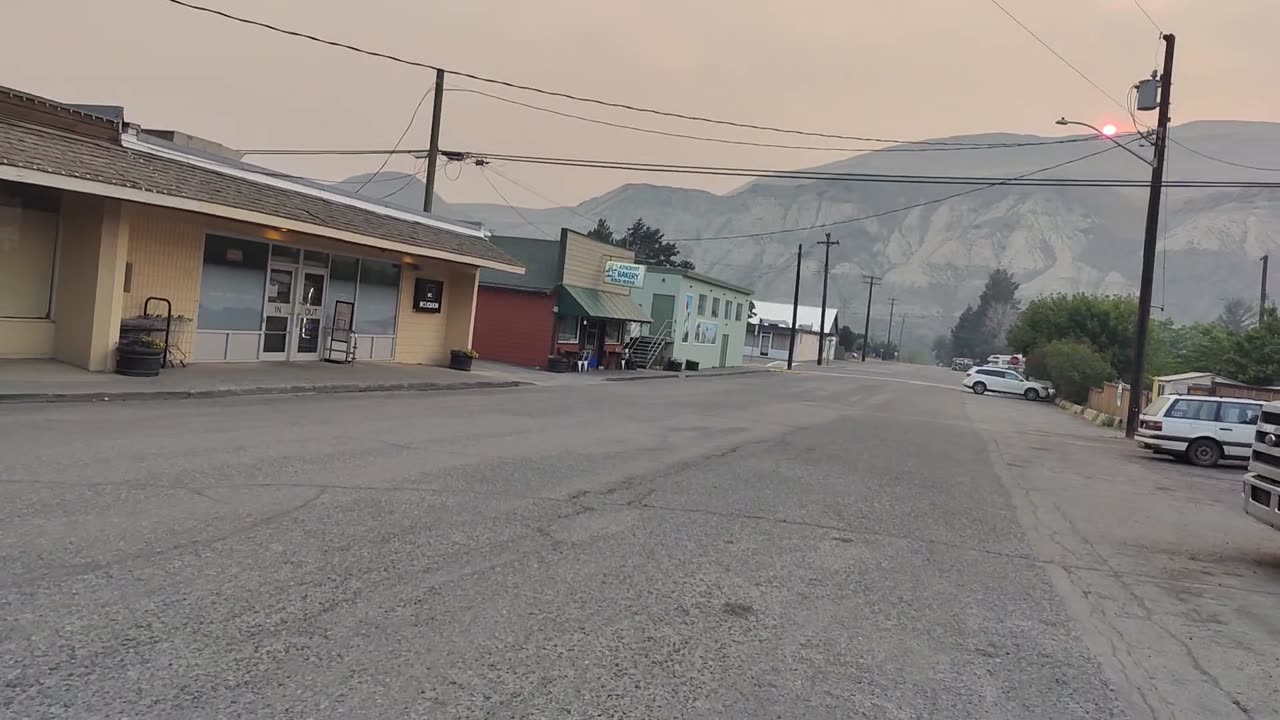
[472,229,652,368]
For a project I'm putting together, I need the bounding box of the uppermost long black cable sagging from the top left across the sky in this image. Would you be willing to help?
[163,0,1116,147]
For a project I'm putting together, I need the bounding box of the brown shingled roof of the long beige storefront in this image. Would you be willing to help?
[0,94,521,269]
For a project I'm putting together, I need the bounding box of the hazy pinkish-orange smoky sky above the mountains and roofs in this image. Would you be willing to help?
[0,0,1280,206]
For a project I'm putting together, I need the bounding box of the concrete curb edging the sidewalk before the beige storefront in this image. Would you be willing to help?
[0,380,532,405]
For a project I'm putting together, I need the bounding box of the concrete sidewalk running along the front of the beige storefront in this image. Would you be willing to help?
[0,360,531,404]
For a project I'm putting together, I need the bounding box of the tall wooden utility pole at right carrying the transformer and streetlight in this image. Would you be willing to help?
[1124,33,1174,439]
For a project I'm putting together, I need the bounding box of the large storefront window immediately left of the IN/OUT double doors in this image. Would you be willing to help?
[197,234,270,331]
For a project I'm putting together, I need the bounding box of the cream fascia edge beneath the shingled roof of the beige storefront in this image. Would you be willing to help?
[0,165,525,275]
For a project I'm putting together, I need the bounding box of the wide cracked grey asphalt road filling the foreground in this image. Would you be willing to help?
[0,363,1280,720]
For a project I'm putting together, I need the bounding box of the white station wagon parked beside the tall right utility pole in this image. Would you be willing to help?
[1134,395,1262,468]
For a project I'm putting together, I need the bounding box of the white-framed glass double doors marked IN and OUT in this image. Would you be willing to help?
[262,264,329,360]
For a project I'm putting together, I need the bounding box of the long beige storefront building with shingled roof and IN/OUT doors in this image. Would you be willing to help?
[0,88,524,370]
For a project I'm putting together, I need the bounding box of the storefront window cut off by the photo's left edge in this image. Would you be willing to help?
[0,183,58,318]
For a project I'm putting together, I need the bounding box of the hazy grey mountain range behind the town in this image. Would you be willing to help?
[340,120,1280,342]
